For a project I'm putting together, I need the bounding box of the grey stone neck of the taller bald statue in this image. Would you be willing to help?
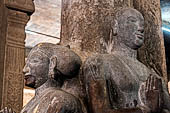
[112,44,137,59]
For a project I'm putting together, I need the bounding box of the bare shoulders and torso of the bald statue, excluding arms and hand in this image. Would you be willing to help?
[85,54,153,109]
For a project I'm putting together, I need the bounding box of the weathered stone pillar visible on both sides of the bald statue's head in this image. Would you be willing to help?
[61,0,167,80]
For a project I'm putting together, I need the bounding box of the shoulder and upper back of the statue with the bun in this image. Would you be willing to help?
[21,87,82,113]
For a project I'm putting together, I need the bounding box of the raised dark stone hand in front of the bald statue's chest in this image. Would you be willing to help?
[140,75,162,113]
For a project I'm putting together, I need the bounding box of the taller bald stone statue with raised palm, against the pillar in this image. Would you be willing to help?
[83,8,170,113]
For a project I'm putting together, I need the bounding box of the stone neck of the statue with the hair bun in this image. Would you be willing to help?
[35,79,61,96]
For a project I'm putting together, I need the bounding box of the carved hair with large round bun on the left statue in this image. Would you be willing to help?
[30,43,82,78]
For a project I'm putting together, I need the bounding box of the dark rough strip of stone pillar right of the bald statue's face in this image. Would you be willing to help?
[133,0,167,82]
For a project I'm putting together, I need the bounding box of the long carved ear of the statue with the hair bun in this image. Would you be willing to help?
[48,56,57,78]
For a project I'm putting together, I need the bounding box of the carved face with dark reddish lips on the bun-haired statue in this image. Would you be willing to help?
[23,51,49,88]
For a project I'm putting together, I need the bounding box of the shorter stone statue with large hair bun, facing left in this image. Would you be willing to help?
[1,43,83,113]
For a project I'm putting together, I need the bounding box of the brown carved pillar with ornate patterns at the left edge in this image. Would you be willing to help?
[0,0,34,113]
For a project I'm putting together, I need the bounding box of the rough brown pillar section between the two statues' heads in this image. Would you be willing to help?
[60,0,133,60]
